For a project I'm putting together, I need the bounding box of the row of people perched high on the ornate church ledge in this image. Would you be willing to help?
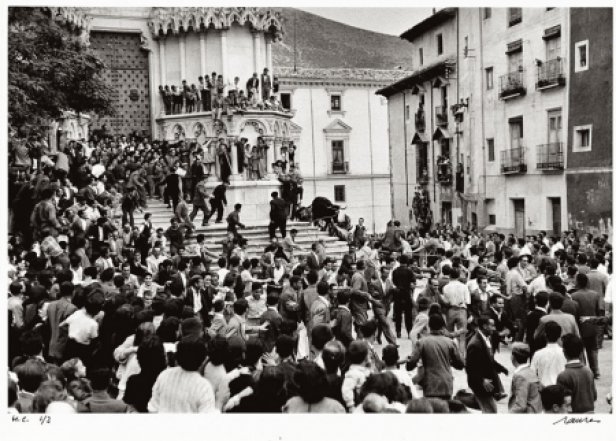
[158,68,290,120]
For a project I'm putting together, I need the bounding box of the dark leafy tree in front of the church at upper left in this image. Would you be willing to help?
[8,7,113,133]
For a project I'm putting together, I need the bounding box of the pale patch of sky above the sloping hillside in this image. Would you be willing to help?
[299,7,432,36]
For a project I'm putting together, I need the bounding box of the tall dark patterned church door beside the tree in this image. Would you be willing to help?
[90,32,150,134]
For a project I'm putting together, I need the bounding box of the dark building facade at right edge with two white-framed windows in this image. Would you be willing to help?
[565,8,614,236]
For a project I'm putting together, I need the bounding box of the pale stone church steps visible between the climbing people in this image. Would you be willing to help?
[129,199,349,267]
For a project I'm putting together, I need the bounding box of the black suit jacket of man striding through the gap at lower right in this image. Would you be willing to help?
[466,332,507,397]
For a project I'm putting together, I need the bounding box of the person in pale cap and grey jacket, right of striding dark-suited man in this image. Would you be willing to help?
[509,342,542,413]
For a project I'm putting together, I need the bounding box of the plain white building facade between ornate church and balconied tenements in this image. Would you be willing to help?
[274,68,405,232]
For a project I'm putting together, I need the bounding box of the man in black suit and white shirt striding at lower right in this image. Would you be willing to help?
[466,315,509,413]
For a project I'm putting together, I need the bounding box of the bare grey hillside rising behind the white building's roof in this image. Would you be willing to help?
[272,8,411,70]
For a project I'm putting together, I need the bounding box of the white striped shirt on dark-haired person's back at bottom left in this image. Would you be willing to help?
[148,367,216,413]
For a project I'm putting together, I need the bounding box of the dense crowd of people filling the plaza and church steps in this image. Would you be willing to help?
[8,125,613,413]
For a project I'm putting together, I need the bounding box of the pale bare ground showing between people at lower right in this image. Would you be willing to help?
[378,330,613,413]
